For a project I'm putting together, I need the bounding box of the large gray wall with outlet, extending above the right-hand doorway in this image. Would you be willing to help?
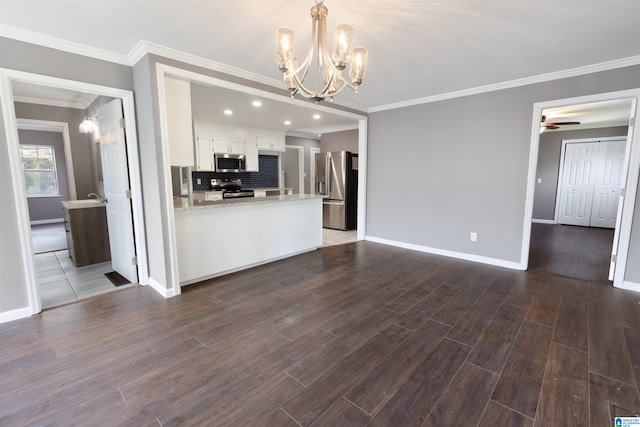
[367,66,640,282]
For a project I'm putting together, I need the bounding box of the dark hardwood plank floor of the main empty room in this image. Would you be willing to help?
[0,242,640,427]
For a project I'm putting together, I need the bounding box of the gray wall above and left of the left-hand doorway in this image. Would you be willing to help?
[0,37,133,314]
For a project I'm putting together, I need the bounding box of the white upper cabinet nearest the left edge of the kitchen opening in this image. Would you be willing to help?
[164,76,194,166]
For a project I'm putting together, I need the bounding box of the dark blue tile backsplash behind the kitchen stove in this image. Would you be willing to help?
[191,154,279,191]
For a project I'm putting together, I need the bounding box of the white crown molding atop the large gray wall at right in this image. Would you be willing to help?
[367,55,640,113]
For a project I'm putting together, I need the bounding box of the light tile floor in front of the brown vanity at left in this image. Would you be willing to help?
[35,250,133,309]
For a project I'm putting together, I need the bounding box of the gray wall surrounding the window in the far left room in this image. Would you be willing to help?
[18,130,69,221]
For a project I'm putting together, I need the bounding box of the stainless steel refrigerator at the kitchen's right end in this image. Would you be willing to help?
[315,151,358,230]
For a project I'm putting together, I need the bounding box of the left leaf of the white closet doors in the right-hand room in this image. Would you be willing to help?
[558,143,598,226]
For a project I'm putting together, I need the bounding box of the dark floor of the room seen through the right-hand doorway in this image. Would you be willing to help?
[529,223,613,280]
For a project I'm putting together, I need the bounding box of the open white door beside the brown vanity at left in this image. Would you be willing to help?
[98,99,138,283]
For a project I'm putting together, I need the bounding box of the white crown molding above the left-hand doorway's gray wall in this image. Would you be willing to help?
[0,25,131,65]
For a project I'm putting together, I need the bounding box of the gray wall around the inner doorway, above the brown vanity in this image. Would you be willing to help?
[15,102,95,199]
